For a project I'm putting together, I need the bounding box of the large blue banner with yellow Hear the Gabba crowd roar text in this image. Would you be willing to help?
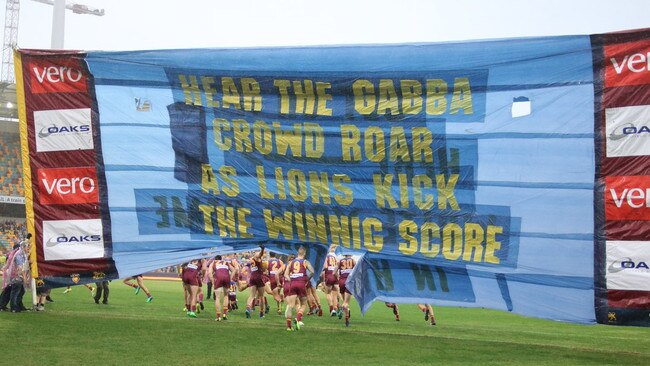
[23,28,644,323]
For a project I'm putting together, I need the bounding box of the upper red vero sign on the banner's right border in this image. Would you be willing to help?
[605,40,650,87]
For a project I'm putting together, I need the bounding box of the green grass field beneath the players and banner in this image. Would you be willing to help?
[0,281,650,366]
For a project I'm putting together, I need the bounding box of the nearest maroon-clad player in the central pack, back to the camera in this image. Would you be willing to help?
[284,246,314,330]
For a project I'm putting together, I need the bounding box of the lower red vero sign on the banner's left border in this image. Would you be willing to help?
[37,167,99,205]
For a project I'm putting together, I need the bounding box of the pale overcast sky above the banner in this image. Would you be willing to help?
[0,0,650,51]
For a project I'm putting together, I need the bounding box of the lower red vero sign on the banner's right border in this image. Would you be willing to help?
[605,176,650,221]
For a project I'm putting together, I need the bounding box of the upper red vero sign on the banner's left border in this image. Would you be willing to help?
[29,59,87,94]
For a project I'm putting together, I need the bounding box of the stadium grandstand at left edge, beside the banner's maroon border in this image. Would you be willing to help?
[0,83,25,255]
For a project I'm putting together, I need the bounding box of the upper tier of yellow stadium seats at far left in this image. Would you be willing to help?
[0,133,25,197]
